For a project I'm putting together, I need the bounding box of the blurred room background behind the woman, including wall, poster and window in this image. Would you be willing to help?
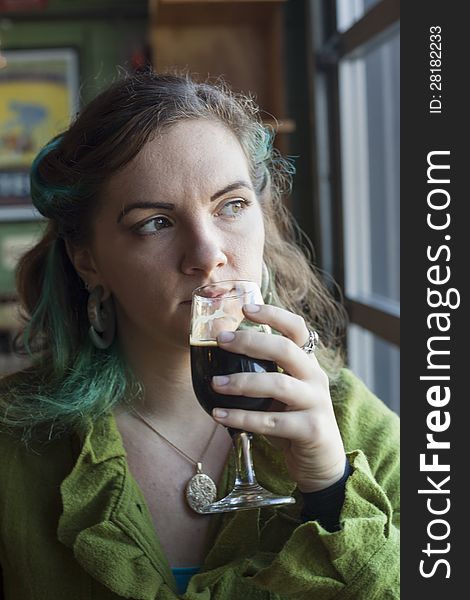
[0,0,400,412]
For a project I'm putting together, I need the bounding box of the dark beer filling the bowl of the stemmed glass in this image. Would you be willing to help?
[191,342,277,414]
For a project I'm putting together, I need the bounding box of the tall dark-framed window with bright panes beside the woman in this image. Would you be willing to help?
[311,0,400,412]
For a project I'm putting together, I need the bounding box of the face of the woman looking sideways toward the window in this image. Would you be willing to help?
[83,120,264,348]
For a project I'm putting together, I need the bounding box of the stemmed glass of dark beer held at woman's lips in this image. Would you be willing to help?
[190,280,295,514]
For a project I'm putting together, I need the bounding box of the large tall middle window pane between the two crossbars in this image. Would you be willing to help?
[339,27,400,314]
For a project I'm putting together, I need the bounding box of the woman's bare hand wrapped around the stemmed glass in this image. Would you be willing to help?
[212,305,345,492]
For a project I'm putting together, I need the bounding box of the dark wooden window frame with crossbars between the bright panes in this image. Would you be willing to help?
[309,0,400,347]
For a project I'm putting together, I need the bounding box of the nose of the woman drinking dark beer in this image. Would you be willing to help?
[181,224,227,276]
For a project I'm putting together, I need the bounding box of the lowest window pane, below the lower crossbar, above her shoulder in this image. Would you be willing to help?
[348,324,400,414]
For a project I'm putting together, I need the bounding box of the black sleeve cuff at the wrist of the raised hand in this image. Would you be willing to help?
[300,459,352,533]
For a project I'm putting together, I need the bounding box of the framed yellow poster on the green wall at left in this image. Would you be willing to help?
[0,48,79,221]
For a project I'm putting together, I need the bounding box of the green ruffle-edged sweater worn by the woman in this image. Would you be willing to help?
[0,370,399,600]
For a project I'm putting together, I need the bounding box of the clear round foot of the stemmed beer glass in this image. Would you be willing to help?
[200,483,295,515]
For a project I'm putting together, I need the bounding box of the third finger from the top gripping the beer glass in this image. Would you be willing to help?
[212,373,312,410]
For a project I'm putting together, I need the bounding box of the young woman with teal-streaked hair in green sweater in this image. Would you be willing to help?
[0,73,399,600]
